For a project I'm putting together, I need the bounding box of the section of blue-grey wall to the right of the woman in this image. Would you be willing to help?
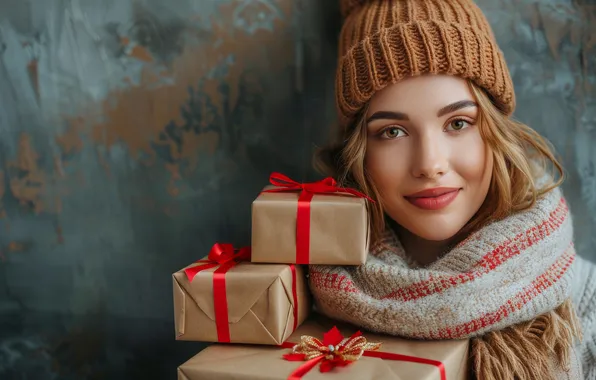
[478,0,596,261]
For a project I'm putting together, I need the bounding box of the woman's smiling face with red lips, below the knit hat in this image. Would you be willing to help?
[365,75,493,241]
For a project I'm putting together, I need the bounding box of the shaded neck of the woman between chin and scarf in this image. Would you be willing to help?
[394,225,456,267]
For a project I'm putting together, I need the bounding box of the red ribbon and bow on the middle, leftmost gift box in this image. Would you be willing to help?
[184,243,298,343]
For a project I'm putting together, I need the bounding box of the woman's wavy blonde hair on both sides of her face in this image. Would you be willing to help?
[314,81,564,246]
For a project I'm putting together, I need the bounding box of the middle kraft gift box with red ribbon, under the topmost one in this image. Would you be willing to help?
[173,243,310,345]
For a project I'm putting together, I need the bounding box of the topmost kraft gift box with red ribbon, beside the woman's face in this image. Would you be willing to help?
[251,173,370,265]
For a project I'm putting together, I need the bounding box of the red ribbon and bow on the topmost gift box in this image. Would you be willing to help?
[263,173,374,264]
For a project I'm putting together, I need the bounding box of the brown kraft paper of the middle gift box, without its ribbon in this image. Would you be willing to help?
[173,262,311,345]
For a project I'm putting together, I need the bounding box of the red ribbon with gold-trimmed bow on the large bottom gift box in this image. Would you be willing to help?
[280,327,447,380]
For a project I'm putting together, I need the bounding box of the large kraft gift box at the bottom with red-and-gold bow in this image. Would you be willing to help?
[178,318,469,380]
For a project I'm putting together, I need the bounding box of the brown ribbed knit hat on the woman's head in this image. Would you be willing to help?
[336,0,515,126]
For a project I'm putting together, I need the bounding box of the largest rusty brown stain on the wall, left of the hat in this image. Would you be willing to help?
[91,32,288,159]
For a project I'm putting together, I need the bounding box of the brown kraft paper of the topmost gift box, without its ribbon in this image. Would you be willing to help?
[251,186,369,265]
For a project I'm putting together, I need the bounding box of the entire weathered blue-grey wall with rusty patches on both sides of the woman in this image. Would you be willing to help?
[0,0,596,380]
